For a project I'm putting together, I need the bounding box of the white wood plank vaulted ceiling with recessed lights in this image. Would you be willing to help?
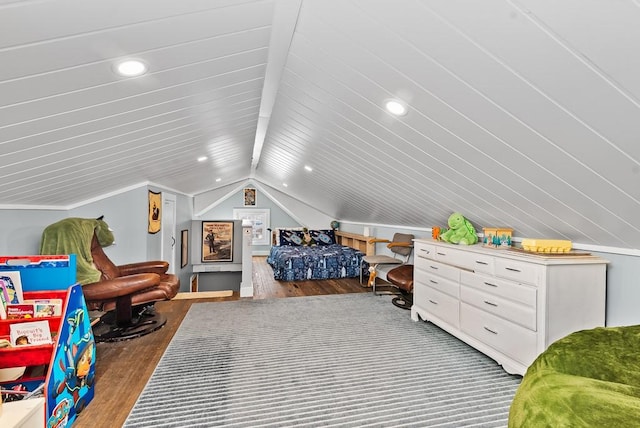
[0,0,640,248]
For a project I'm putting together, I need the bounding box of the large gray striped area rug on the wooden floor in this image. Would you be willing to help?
[125,293,520,427]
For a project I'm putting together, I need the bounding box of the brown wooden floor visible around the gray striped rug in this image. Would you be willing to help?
[74,257,380,428]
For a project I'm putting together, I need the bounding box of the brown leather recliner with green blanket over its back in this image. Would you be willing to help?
[40,217,180,342]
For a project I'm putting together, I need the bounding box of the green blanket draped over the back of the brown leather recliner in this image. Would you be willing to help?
[40,217,114,285]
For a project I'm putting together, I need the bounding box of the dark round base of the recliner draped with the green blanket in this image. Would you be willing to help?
[92,307,167,342]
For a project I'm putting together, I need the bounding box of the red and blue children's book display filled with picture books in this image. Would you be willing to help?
[0,255,96,427]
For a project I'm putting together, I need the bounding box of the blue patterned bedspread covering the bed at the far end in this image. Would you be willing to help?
[267,244,366,281]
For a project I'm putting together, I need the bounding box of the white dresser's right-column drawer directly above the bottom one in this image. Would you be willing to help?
[460,285,536,331]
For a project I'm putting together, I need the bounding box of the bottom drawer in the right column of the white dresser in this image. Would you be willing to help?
[460,303,538,366]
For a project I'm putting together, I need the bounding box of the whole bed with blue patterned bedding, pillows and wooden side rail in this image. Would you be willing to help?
[267,228,375,281]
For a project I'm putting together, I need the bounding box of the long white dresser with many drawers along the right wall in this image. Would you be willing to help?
[411,239,607,375]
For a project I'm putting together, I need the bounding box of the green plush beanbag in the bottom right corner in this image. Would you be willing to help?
[509,326,640,428]
